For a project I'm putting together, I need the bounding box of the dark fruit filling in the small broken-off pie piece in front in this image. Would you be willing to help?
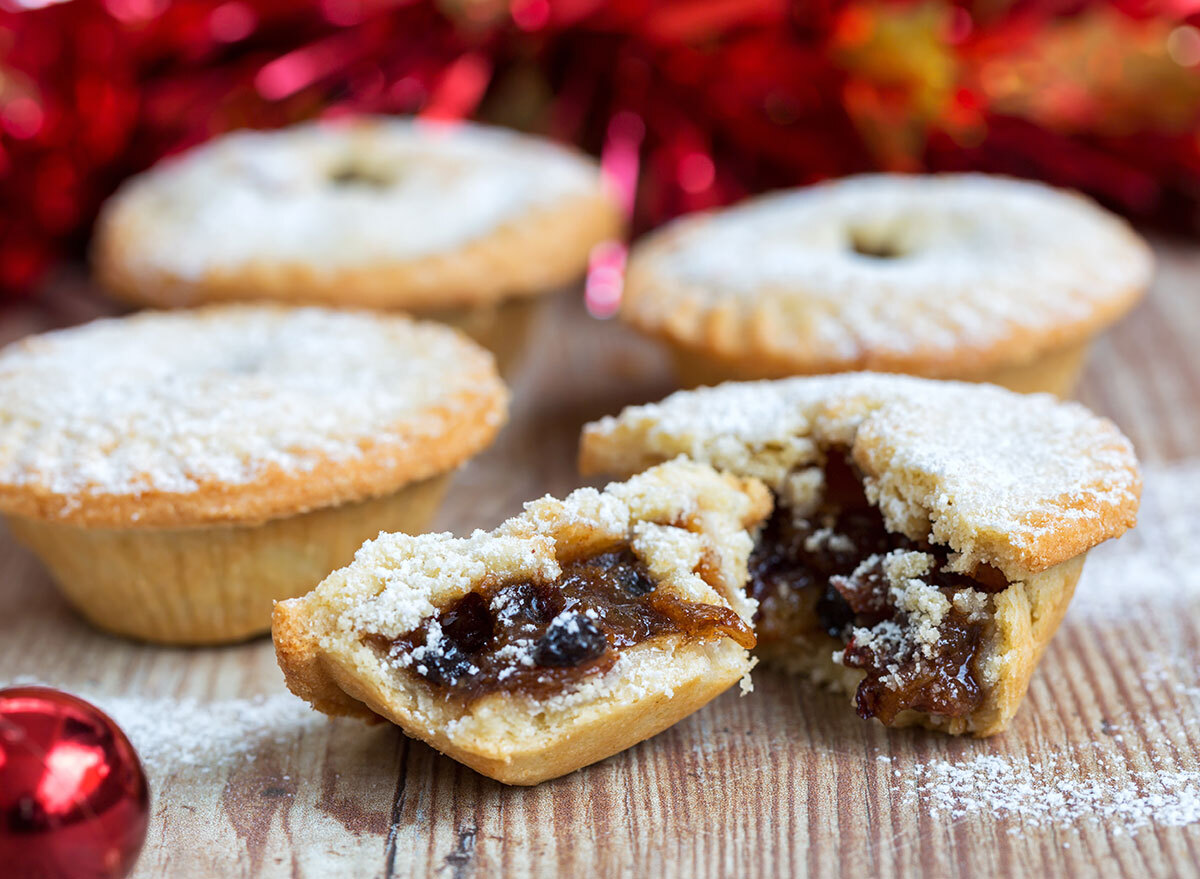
[365,548,755,702]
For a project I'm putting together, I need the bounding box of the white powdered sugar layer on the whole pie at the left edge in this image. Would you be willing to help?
[0,306,499,496]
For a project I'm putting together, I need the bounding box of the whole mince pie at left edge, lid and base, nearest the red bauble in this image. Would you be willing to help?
[0,305,508,644]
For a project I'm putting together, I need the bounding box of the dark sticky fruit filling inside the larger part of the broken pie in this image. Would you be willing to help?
[748,454,1008,724]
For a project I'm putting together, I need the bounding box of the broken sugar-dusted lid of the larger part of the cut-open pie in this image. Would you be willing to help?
[581,373,1141,580]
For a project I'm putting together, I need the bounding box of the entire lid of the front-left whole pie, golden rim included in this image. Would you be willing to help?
[0,306,508,526]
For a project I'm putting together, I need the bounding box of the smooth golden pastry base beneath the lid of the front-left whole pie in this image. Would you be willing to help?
[7,474,450,645]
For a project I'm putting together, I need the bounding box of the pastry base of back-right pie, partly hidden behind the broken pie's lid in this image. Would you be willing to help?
[671,339,1092,399]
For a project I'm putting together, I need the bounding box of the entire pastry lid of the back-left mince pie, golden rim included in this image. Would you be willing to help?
[94,116,620,309]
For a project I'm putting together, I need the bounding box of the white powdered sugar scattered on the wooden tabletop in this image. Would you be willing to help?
[4,461,1200,844]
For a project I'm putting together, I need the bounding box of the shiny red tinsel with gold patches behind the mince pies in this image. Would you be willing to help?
[0,0,1200,299]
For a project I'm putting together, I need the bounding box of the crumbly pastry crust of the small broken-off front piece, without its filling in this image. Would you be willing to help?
[272,461,770,784]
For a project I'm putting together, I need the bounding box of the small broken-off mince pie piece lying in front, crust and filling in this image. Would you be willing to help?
[272,461,770,784]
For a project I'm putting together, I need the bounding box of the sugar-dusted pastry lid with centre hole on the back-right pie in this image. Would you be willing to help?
[623,174,1152,377]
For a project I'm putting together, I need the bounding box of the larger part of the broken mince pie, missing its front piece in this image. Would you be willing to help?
[581,373,1141,736]
